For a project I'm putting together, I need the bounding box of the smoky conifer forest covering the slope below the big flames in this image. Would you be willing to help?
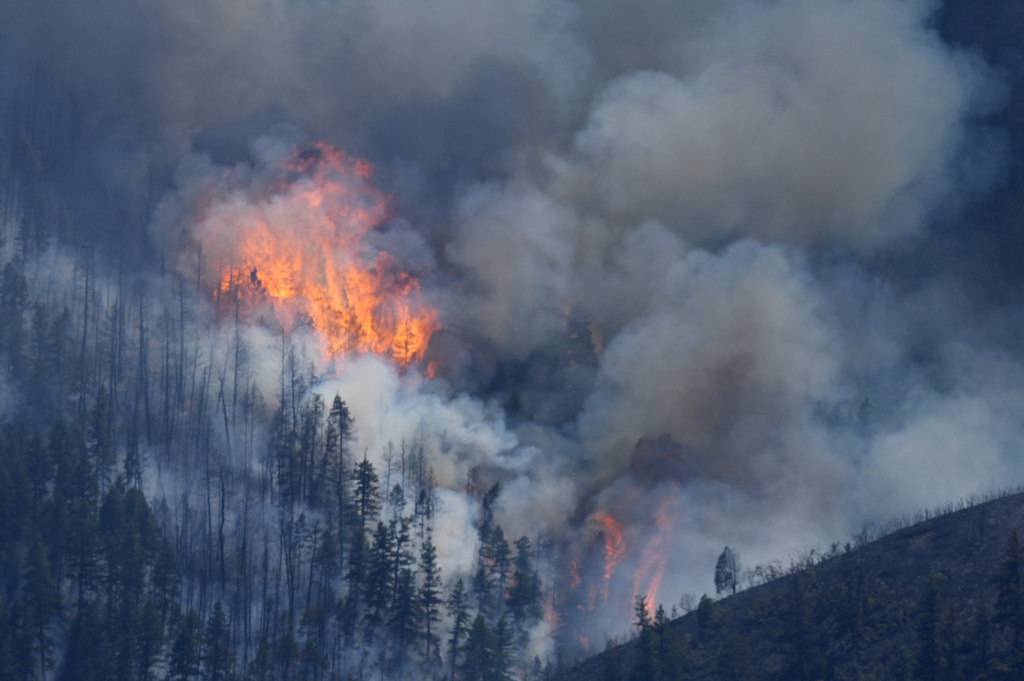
[0,241,551,680]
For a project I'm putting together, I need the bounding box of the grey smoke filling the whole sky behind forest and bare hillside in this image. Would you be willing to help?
[0,0,1024,643]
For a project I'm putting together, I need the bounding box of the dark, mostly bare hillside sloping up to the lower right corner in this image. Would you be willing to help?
[557,494,1024,681]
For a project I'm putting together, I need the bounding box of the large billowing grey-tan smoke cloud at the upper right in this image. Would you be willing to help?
[568,1,977,250]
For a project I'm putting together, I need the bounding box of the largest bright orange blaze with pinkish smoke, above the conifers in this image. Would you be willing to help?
[196,143,439,366]
